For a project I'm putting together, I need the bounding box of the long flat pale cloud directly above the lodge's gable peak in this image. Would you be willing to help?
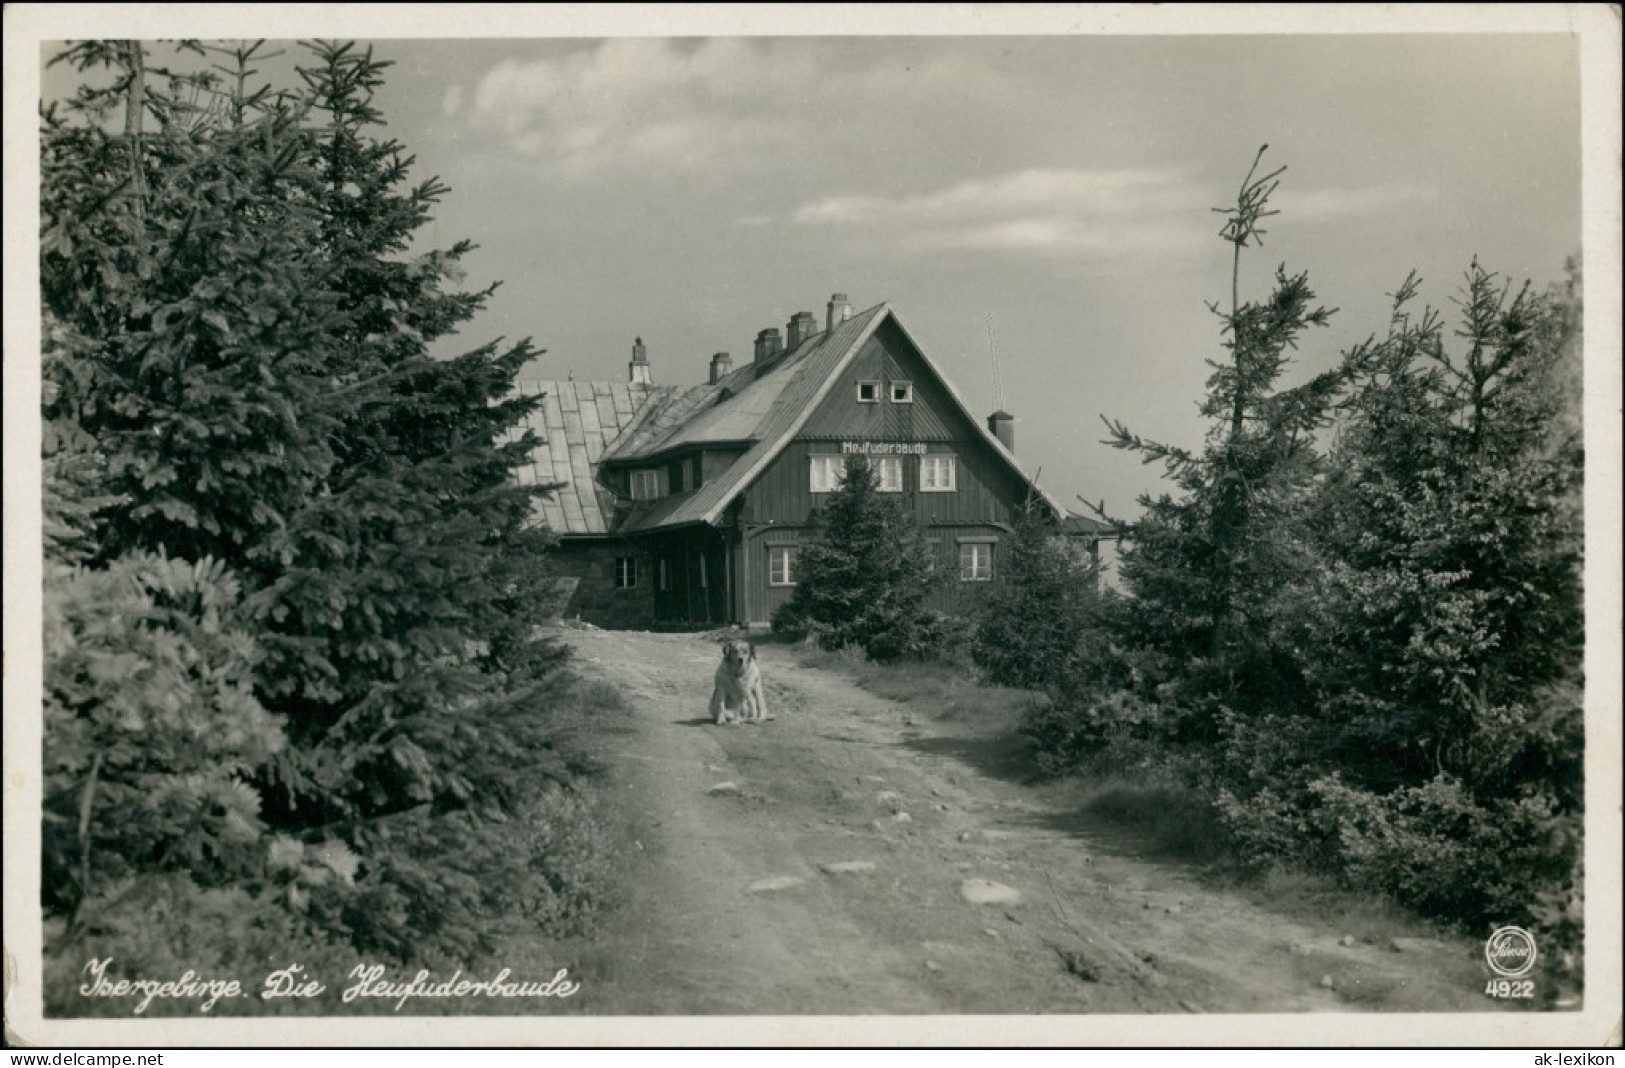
[791,167,1214,258]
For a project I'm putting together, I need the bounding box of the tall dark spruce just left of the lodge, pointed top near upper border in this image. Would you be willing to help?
[248,44,556,816]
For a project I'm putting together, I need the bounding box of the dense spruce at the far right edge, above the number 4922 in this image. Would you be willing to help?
[1267,263,1584,936]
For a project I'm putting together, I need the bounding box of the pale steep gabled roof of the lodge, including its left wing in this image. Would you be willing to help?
[518,297,1066,535]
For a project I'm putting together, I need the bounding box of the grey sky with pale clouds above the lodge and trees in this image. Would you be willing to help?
[28,8,1581,517]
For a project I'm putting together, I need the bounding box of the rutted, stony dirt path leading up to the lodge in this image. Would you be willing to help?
[548,631,1493,1014]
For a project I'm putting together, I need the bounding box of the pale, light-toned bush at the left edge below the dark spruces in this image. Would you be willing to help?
[42,553,284,910]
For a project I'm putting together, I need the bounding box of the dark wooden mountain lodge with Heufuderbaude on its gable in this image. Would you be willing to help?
[518,287,1105,627]
